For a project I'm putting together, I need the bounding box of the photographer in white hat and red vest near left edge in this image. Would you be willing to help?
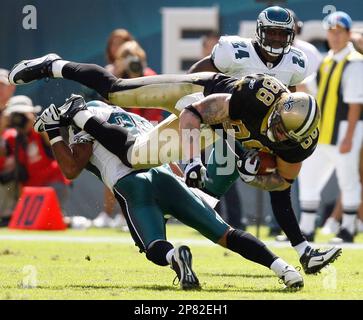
[0,96,70,225]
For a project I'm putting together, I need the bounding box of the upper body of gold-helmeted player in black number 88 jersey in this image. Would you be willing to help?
[179,74,320,190]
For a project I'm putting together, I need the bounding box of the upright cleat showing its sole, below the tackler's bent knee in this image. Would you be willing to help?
[171,246,200,290]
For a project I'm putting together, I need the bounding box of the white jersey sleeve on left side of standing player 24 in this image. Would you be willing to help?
[211,36,240,73]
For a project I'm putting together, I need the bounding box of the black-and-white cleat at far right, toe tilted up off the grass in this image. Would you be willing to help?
[300,247,342,274]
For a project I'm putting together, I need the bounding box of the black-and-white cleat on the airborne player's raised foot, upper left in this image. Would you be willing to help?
[9,53,62,85]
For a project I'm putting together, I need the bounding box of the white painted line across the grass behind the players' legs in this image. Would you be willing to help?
[0,234,363,250]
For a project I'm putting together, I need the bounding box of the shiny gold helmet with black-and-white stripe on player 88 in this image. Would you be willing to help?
[267,92,320,143]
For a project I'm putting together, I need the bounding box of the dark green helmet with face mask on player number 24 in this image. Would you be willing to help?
[256,6,295,56]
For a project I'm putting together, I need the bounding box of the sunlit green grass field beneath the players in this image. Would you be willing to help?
[0,225,363,300]
